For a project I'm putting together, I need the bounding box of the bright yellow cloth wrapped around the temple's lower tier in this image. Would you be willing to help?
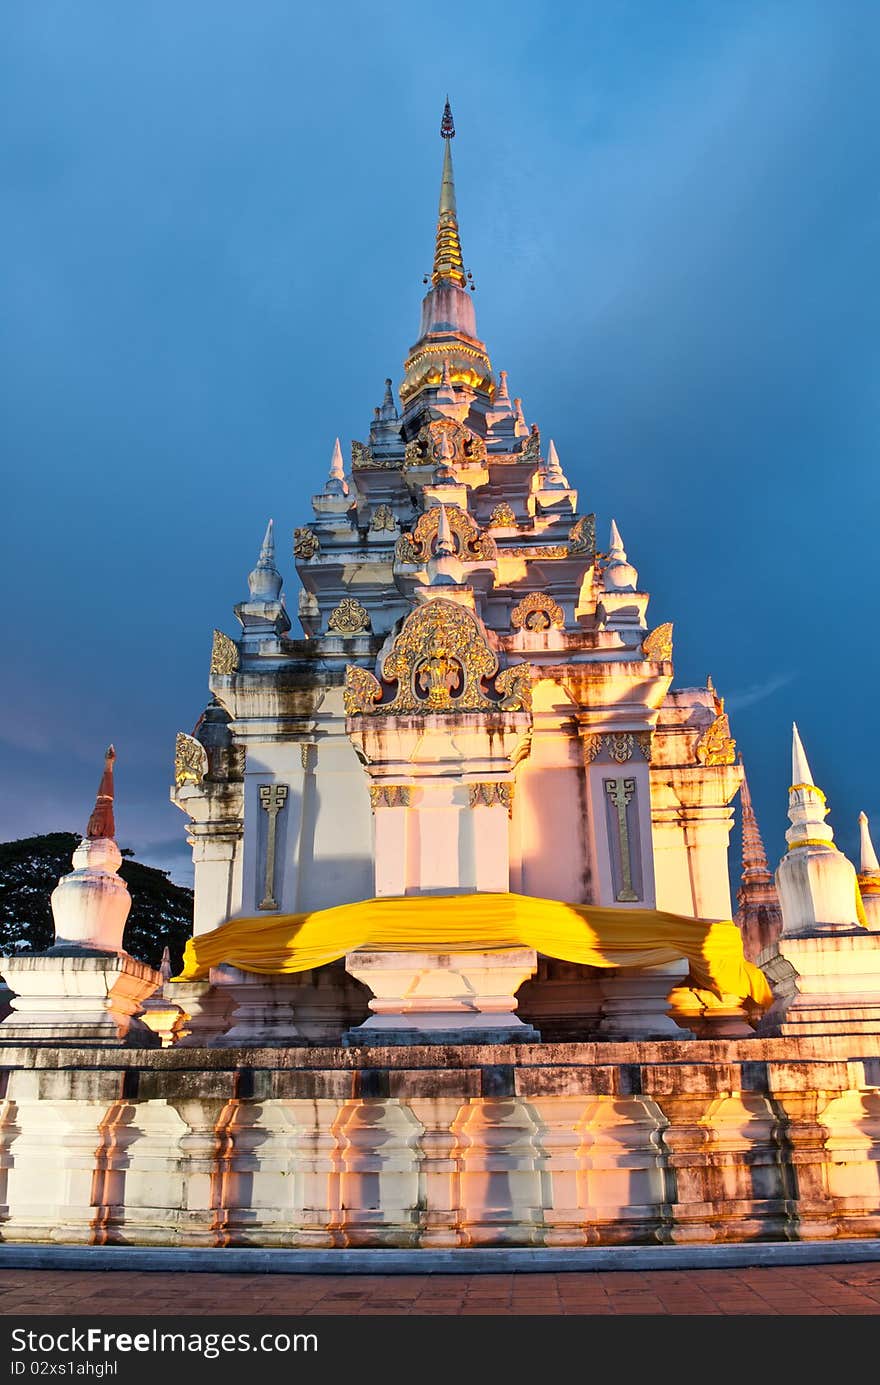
[175,893,773,1008]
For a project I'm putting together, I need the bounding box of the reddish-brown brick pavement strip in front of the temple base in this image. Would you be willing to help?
[0,1262,880,1317]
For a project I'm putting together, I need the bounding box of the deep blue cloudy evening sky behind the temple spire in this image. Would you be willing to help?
[0,0,880,878]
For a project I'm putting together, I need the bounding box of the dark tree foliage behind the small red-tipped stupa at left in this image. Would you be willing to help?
[0,832,193,970]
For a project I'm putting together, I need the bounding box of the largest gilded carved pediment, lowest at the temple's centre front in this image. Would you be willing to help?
[345,598,532,716]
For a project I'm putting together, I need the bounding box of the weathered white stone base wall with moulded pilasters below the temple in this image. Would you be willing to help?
[0,1035,880,1249]
